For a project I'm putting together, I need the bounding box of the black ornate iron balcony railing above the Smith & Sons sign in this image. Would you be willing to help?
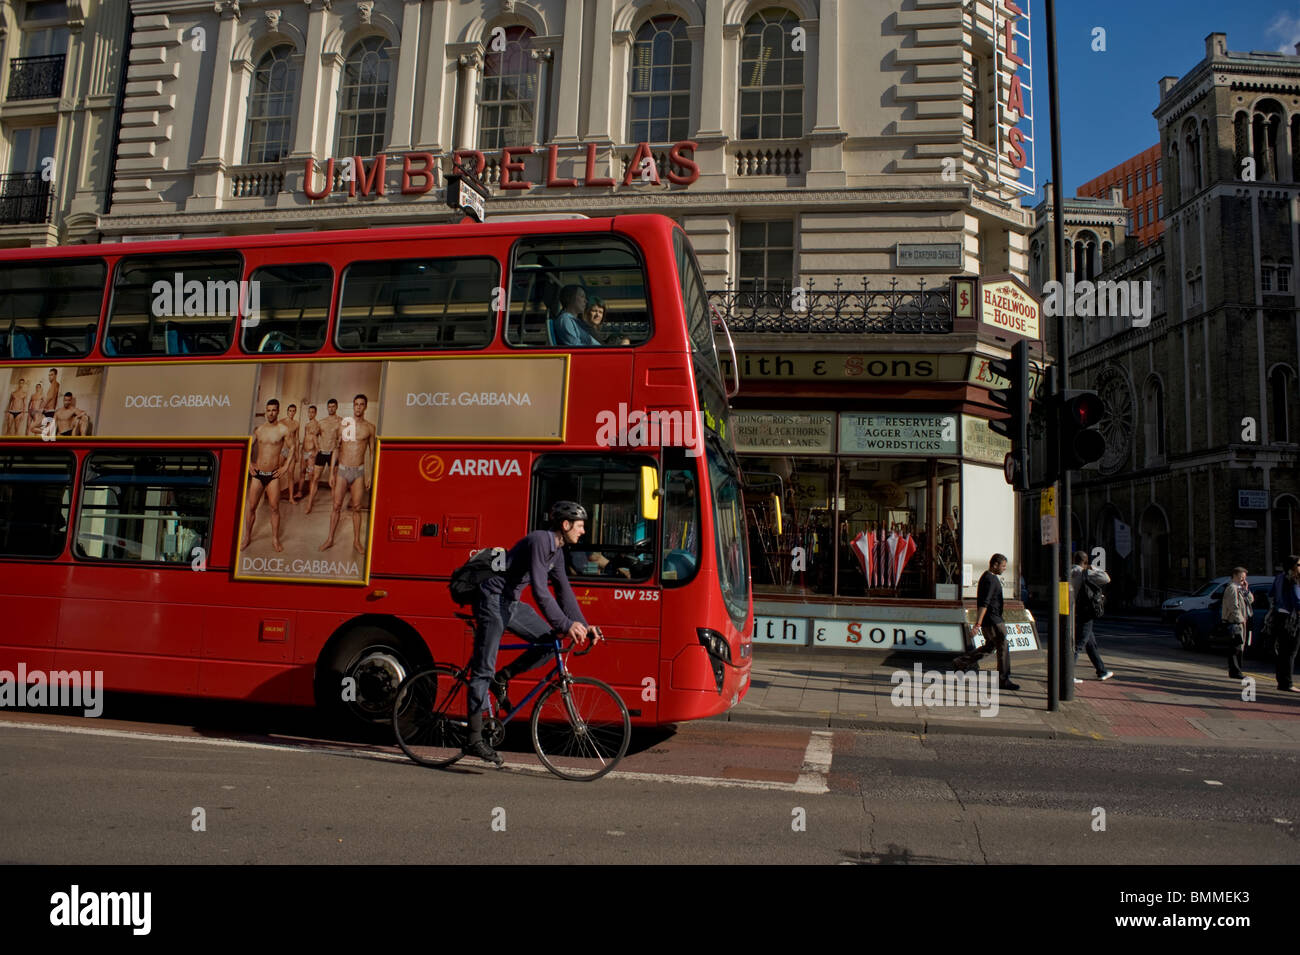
[709,278,953,335]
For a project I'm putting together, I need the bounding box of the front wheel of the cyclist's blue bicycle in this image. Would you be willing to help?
[532,677,632,782]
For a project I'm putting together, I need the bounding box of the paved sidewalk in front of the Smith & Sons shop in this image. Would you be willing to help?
[716,646,1300,747]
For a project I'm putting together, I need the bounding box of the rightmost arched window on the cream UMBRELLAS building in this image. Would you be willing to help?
[740,8,803,139]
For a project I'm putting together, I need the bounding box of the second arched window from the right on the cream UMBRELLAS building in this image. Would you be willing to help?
[629,17,690,143]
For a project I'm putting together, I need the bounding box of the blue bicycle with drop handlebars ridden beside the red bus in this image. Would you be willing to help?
[393,630,632,782]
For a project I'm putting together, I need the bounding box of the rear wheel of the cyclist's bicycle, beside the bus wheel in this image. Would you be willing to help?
[393,664,469,767]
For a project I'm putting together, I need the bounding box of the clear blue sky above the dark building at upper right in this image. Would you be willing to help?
[1019,0,1300,204]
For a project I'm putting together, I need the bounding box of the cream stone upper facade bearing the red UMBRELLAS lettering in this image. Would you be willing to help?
[91,0,1028,290]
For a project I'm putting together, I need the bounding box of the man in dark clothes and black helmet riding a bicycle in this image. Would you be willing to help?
[463,500,601,765]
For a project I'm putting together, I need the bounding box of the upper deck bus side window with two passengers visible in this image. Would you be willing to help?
[506,235,653,348]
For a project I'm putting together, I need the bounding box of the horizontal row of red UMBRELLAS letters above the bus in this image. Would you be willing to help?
[299,139,699,200]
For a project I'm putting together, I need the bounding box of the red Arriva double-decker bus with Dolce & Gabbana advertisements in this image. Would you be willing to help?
[0,216,753,725]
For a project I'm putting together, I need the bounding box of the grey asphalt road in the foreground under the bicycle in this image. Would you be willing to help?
[0,711,1300,864]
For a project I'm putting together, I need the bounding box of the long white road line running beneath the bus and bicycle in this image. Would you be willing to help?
[0,720,831,795]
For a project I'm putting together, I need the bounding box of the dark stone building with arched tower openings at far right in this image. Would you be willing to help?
[1030,34,1300,605]
